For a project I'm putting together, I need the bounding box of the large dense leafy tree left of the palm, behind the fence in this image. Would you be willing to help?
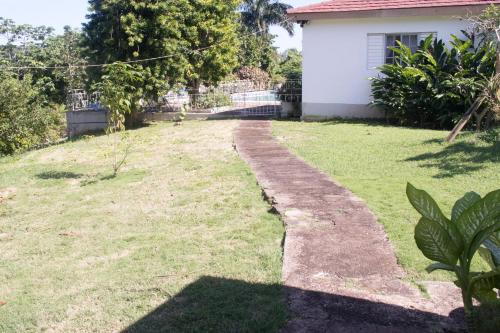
[84,0,239,101]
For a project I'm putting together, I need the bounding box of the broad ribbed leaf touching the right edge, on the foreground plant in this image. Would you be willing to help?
[456,190,500,249]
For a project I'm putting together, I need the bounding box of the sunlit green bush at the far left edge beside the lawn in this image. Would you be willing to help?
[0,76,64,155]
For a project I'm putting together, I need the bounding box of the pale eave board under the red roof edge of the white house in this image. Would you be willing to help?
[287,5,488,22]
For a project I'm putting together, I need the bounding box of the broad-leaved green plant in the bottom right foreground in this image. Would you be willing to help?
[406,184,500,332]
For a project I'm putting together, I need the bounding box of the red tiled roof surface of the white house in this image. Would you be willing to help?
[288,0,500,14]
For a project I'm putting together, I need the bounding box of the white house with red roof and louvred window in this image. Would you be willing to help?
[288,0,500,120]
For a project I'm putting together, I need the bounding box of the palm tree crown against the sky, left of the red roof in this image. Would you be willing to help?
[241,0,293,36]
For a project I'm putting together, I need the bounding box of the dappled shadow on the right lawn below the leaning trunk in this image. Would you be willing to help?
[405,139,500,178]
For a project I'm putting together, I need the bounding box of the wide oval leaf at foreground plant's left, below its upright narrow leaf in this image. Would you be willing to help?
[415,217,461,266]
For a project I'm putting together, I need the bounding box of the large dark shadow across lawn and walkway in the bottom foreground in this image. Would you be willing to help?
[122,277,463,333]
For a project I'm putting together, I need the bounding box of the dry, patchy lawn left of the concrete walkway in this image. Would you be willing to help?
[0,121,288,333]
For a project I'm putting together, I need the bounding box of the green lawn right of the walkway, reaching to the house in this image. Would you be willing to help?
[273,122,500,282]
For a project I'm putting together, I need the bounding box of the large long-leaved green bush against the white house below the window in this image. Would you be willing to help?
[371,36,496,128]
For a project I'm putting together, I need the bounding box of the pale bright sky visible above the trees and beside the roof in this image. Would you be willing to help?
[0,0,316,51]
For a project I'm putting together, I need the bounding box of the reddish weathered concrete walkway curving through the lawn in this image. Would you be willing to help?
[235,121,463,333]
